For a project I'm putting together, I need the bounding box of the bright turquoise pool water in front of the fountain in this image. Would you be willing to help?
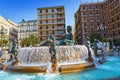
[0,56,120,80]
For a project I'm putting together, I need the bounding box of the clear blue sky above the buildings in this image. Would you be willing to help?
[0,0,101,26]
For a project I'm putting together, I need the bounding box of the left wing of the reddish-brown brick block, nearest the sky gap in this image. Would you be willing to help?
[75,3,103,44]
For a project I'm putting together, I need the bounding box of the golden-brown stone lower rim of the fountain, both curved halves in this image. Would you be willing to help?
[3,62,95,74]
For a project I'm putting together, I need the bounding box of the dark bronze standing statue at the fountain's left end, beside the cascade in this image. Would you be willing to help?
[8,40,18,61]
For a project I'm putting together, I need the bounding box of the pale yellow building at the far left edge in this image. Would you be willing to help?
[0,16,17,48]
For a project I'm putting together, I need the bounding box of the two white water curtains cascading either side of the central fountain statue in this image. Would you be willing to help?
[18,45,88,66]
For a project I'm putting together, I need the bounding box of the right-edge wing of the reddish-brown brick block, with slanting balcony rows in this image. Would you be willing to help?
[103,0,120,39]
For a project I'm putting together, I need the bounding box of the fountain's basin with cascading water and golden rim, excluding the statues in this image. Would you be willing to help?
[3,45,104,73]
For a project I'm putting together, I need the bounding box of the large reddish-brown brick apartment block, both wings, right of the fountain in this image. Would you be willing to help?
[75,0,120,44]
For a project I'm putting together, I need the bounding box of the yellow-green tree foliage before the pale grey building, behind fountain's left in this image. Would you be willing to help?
[21,34,39,46]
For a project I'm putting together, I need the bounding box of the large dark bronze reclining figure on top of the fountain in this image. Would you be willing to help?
[57,26,74,45]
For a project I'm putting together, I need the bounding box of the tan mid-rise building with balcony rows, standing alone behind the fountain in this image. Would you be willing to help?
[37,6,66,41]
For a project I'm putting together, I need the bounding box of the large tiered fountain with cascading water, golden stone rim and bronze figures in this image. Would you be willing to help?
[3,26,105,74]
